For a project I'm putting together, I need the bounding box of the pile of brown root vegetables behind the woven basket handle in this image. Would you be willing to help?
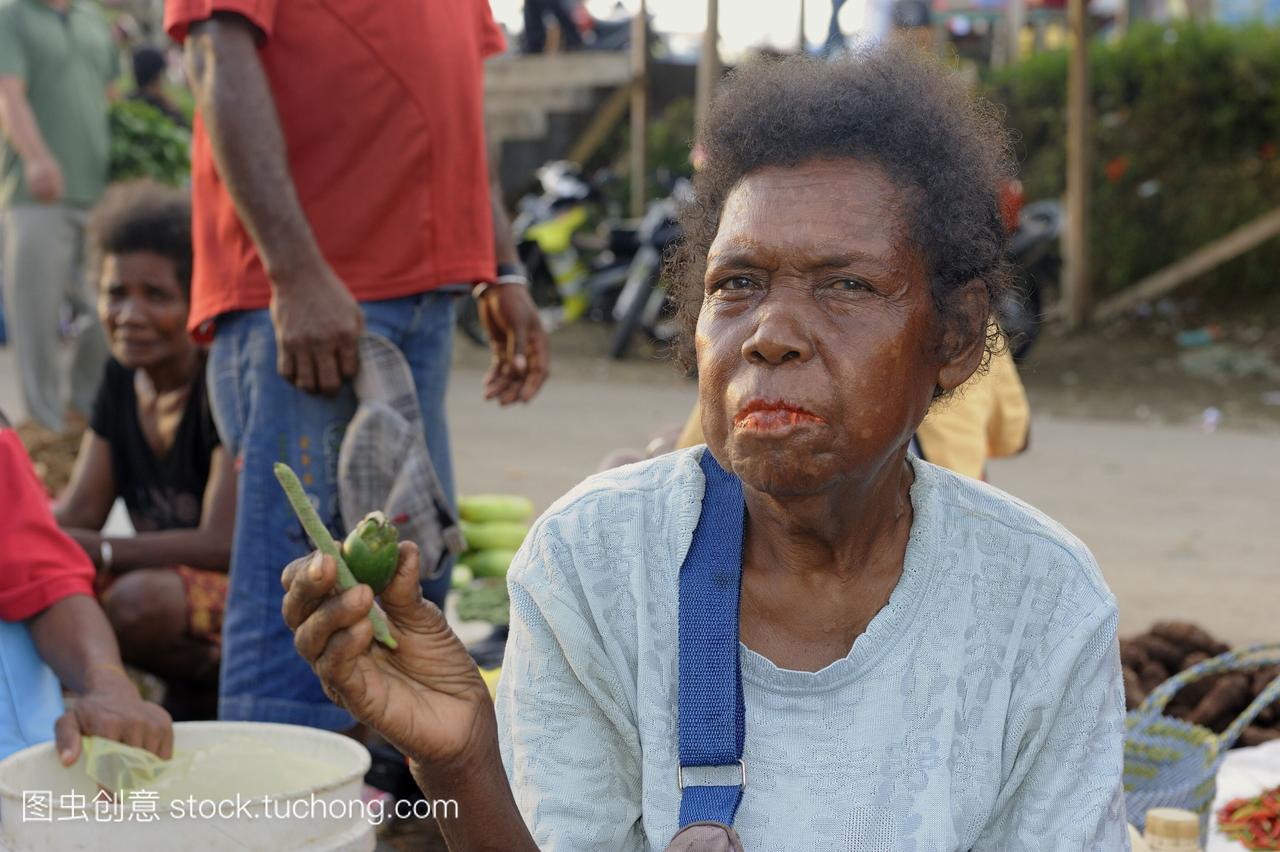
[1120,622,1280,746]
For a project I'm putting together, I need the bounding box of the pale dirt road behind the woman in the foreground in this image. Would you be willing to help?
[448,312,1280,643]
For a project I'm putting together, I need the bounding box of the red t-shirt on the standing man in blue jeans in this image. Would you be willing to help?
[165,0,504,330]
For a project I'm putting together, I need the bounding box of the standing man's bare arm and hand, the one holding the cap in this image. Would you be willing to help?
[186,14,364,394]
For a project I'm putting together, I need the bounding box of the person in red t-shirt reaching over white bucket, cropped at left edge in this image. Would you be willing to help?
[0,413,173,766]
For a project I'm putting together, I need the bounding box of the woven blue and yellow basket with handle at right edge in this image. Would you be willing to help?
[1124,642,1280,846]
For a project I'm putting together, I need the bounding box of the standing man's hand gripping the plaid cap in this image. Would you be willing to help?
[271,264,365,397]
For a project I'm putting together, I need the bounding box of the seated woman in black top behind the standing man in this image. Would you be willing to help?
[55,182,236,718]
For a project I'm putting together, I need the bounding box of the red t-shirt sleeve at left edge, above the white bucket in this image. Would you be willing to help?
[0,429,93,622]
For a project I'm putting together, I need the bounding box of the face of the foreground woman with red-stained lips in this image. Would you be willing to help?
[696,160,972,496]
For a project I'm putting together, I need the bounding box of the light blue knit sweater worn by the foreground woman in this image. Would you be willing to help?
[498,448,1128,852]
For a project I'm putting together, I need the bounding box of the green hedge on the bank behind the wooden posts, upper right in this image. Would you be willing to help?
[987,24,1280,294]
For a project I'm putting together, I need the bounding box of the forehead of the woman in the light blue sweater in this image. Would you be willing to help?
[708,160,905,264]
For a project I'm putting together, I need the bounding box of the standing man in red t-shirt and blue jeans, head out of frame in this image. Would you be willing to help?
[165,0,548,729]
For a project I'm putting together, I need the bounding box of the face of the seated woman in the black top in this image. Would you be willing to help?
[97,252,193,368]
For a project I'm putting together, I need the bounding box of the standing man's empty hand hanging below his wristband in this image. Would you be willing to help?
[479,284,550,406]
